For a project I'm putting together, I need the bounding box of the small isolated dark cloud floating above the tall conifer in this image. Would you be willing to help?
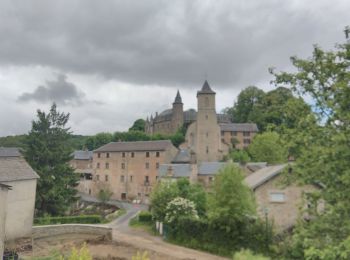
[18,74,85,105]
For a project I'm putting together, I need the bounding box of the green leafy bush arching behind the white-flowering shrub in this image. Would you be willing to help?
[150,179,207,221]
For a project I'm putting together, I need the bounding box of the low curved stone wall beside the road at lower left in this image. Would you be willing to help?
[32,224,112,239]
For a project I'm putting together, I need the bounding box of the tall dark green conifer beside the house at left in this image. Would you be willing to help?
[25,104,78,215]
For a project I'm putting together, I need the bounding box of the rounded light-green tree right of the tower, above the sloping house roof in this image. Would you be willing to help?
[248,132,288,164]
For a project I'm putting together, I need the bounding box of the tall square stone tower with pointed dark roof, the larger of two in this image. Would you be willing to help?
[195,81,221,162]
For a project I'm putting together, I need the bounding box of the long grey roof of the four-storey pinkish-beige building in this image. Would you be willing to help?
[94,140,172,152]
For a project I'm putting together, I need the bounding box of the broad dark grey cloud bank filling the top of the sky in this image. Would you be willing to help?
[0,0,349,88]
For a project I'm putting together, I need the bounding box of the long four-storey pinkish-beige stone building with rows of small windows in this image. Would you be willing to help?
[92,140,178,202]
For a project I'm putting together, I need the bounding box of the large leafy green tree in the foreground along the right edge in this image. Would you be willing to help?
[271,30,350,259]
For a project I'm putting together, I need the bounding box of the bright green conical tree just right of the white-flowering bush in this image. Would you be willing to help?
[208,164,256,231]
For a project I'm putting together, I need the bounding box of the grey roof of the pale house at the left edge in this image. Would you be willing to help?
[0,156,39,182]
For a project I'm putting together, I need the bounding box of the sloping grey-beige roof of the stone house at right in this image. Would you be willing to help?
[244,164,288,190]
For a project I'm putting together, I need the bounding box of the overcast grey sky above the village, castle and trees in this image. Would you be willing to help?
[0,0,350,136]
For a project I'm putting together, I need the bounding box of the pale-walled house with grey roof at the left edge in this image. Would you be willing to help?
[0,148,39,241]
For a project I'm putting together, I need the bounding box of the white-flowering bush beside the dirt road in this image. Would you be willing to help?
[164,197,199,223]
